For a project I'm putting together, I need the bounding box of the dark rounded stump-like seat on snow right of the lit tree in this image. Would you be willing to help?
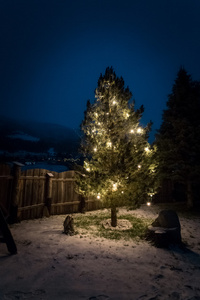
[147,210,182,248]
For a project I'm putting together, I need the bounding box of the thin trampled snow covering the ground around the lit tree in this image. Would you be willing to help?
[0,206,200,300]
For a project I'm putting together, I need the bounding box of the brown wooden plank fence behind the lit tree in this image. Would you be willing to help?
[0,163,101,220]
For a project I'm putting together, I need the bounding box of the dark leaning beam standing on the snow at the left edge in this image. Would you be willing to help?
[0,208,17,254]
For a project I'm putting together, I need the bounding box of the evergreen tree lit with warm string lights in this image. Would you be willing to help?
[78,68,154,226]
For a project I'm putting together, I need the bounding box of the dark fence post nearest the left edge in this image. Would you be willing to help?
[9,162,23,223]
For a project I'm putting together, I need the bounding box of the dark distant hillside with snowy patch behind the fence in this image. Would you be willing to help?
[0,117,80,155]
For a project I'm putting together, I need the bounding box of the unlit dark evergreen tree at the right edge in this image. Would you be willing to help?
[156,68,200,207]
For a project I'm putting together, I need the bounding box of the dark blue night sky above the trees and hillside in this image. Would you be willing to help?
[0,0,200,138]
